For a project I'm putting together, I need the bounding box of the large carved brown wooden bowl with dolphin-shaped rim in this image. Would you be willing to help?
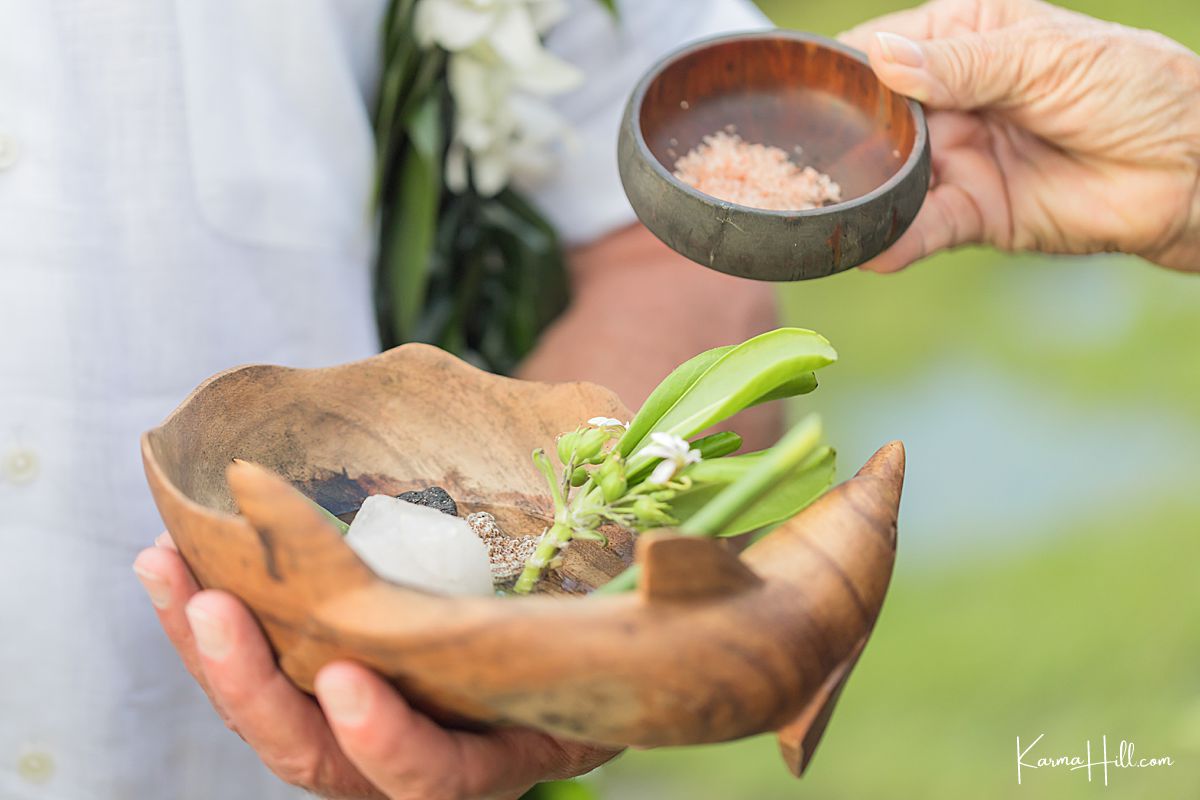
[142,344,904,774]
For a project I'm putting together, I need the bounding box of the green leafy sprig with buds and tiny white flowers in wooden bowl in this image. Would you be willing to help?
[514,329,838,594]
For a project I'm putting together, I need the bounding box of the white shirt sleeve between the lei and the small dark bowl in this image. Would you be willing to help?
[527,0,770,245]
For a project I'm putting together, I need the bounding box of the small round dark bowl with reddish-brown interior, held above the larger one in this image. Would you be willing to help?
[618,31,930,281]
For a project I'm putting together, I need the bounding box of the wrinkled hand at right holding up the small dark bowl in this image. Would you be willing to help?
[841,0,1200,272]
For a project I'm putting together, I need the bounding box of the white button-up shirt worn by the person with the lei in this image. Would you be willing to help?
[0,0,762,800]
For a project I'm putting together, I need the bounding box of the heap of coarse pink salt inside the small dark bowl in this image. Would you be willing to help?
[674,127,841,211]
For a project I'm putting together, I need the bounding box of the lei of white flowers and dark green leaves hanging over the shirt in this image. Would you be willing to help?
[376,0,616,372]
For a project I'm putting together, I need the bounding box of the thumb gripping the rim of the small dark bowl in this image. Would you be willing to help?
[869,29,1028,112]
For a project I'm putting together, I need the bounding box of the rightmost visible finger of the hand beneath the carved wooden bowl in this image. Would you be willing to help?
[316,662,613,800]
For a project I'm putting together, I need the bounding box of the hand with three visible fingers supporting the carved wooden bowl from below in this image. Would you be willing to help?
[133,534,617,800]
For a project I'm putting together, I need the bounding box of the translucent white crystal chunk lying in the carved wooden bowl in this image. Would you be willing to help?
[346,494,493,595]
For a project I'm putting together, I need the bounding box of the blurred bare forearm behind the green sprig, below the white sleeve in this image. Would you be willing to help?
[520,224,782,449]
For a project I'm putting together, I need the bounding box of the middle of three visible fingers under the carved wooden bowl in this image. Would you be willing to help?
[187,591,379,798]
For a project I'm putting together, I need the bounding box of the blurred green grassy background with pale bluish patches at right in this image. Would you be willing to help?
[568,0,1200,800]
